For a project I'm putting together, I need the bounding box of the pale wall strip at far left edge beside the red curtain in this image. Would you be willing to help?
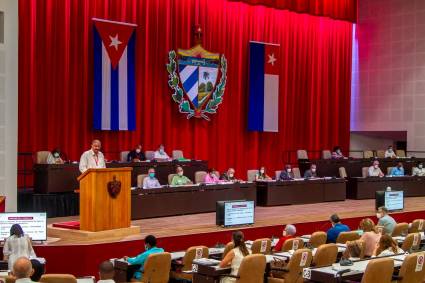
[0,0,18,211]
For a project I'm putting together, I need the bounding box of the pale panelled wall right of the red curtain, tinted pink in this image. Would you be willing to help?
[351,0,425,151]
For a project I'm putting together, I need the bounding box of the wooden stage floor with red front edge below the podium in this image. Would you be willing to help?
[34,197,425,276]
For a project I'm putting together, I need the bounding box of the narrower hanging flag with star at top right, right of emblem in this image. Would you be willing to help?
[248,41,280,132]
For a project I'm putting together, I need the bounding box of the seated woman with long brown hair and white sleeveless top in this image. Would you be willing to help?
[220,231,251,283]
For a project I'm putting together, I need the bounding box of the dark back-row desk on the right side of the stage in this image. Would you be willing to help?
[298,158,425,177]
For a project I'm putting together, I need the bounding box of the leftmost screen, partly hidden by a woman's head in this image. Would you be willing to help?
[0,212,47,241]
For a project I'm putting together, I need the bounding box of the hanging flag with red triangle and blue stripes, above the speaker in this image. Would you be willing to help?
[93,19,136,131]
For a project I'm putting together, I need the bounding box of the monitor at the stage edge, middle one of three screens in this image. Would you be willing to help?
[216,200,255,227]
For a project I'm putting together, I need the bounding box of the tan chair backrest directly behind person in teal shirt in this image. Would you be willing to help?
[143,253,171,283]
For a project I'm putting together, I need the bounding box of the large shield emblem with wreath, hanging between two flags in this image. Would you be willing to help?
[167,44,227,121]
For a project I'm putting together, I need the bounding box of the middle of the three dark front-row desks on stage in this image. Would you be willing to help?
[257,178,346,206]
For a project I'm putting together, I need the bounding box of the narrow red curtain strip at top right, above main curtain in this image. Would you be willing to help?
[227,0,357,22]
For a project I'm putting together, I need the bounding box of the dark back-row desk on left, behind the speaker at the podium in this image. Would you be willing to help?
[33,160,208,194]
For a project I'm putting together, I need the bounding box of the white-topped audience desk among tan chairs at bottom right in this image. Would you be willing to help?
[303,254,406,283]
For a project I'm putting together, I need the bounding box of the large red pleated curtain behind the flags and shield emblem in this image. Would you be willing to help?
[19,0,352,178]
